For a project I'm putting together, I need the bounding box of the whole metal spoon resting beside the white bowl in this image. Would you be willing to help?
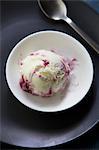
[38,0,99,54]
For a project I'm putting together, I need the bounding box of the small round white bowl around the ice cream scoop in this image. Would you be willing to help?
[6,31,93,112]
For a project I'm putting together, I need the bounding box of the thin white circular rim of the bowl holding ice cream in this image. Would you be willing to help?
[5,30,94,113]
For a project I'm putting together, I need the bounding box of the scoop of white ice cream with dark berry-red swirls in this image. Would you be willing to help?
[20,50,71,96]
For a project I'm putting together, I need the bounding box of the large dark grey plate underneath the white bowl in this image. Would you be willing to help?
[0,1,99,147]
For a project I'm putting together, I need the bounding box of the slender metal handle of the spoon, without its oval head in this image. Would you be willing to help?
[63,17,99,54]
